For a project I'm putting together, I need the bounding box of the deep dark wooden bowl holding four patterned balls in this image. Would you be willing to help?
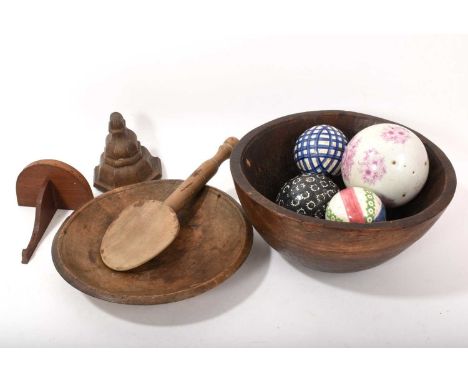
[231,110,456,272]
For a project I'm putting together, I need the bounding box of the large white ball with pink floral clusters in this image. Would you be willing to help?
[341,123,429,207]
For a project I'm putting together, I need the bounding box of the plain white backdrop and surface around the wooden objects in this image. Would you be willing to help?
[0,2,468,346]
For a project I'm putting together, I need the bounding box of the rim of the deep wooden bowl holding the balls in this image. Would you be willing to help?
[230,110,457,231]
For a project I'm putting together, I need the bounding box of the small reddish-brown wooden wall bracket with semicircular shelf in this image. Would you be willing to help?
[16,159,93,264]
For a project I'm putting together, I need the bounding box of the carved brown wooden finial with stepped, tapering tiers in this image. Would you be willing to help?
[94,112,162,192]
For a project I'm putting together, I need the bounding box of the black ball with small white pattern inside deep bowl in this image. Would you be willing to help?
[276,174,339,219]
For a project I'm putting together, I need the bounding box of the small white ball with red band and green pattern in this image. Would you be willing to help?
[325,187,386,223]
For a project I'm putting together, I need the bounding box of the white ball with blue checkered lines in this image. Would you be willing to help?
[294,125,348,175]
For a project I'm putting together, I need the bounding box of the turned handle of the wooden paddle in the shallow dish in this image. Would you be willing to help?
[164,137,239,212]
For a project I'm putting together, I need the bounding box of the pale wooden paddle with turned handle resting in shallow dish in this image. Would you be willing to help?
[101,137,239,271]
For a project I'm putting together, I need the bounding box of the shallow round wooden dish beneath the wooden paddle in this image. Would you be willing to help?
[52,180,252,305]
